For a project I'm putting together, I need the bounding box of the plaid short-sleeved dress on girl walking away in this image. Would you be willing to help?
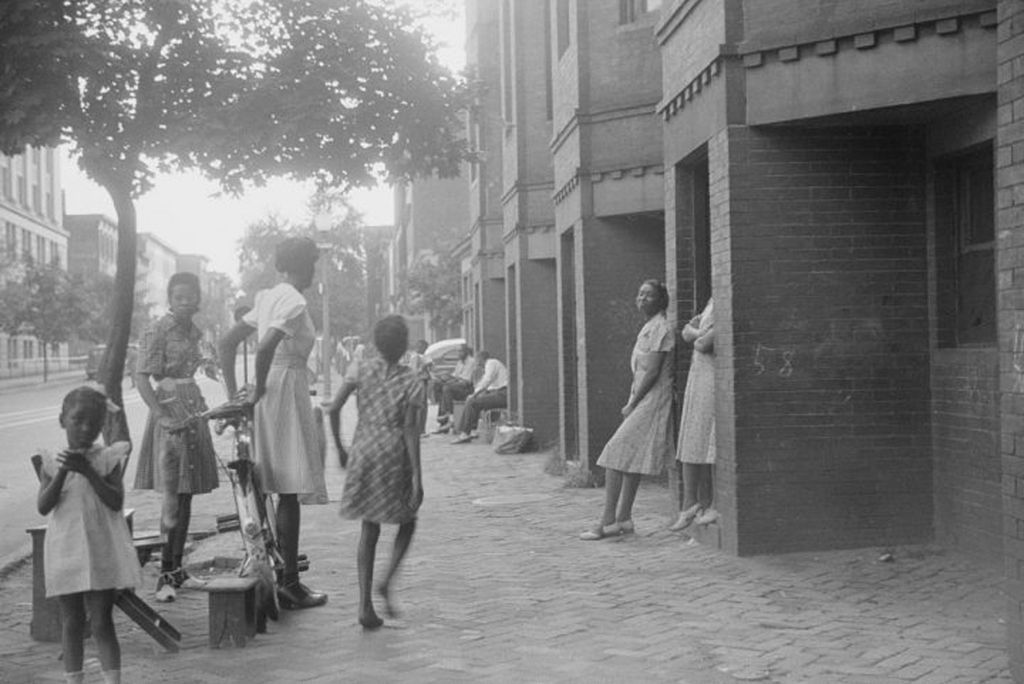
[341,358,425,523]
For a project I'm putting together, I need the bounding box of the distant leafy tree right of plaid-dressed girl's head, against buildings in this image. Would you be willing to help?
[404,250,462,335]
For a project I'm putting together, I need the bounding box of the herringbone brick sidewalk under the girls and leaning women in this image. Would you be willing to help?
[0,423,1011,684]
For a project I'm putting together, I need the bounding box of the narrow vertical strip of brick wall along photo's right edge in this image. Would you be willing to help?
[995,0,1024,681]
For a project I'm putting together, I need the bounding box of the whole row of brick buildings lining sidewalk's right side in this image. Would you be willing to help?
[461,0,1024,681]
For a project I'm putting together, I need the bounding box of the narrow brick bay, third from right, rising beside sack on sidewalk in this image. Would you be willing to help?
[495,1,559,444]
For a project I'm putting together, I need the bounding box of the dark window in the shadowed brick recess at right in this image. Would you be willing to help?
[935,143,996,347]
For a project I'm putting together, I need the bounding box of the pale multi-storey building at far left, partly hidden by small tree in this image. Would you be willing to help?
[0,147,68,376]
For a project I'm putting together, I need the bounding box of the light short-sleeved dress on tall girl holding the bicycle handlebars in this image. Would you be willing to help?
[243,283,327,504]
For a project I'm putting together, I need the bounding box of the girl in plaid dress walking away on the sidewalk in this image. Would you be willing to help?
[329,315,426,630]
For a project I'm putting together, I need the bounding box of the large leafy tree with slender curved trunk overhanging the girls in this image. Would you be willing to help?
[0,0,464,437]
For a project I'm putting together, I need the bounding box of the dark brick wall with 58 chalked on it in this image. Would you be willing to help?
[711,127,932,553]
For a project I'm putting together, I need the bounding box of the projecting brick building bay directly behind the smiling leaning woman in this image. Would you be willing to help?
[548,0,666,464]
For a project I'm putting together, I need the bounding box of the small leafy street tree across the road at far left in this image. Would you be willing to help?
[0,260,86,382]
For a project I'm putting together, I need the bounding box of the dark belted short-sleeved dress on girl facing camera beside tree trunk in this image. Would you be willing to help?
[135,313,218,494]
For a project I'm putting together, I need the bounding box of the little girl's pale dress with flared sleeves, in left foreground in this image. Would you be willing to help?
[42,441,142,597]
